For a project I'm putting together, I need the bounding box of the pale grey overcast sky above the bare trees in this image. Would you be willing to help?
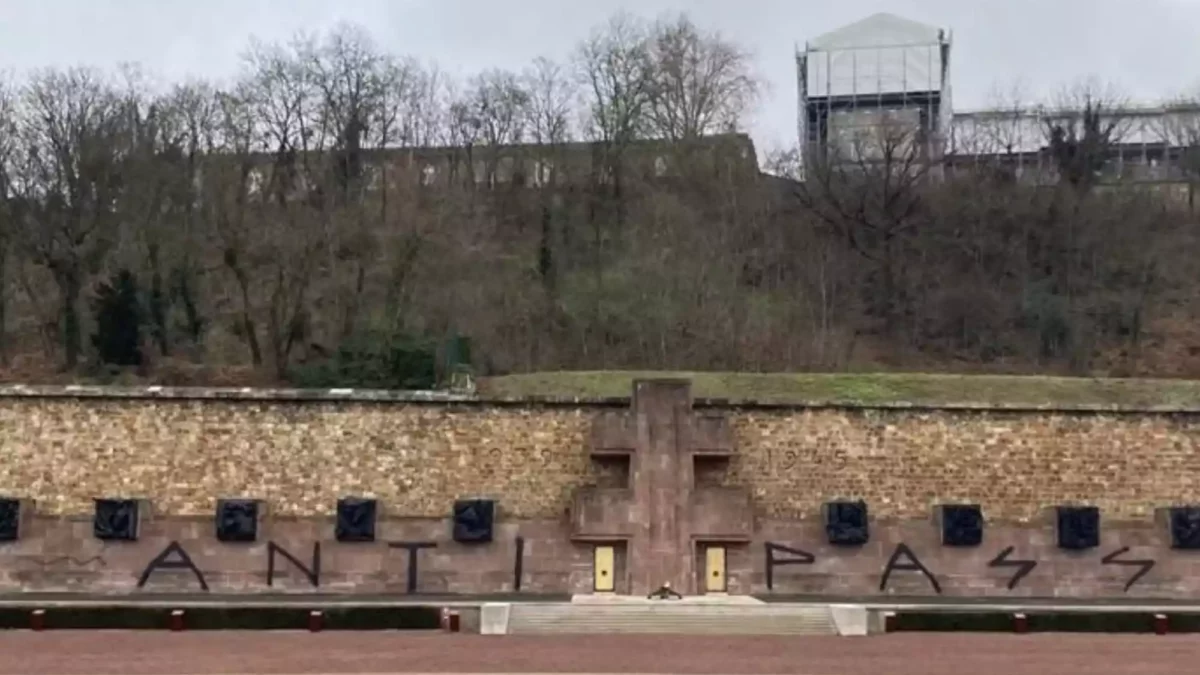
[7,0,1200,150]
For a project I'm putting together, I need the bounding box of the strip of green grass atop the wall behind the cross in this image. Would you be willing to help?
[480,371,1200,407]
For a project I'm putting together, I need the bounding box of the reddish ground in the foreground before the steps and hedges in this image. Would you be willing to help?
[0,631,1200,675]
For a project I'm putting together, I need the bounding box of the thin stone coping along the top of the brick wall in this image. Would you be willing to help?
[0,384,1200,414]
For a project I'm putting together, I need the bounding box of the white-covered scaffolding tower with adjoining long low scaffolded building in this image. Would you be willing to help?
[796,13,1200,198]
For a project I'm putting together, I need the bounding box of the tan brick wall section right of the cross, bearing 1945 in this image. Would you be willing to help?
[731,410,1200,522]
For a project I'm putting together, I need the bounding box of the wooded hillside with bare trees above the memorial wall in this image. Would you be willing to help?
[0,20,1200,389]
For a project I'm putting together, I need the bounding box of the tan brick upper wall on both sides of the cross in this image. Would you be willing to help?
[0,390,1200,521]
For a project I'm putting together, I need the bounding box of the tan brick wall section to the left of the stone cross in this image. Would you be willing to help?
[0,398,598,518]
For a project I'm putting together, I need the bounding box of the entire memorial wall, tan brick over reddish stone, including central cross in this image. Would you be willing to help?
[0,382,1200,598]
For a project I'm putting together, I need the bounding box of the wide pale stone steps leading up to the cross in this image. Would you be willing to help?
[508,603,838,635]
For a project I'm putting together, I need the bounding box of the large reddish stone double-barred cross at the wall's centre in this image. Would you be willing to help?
[572,380,752,596]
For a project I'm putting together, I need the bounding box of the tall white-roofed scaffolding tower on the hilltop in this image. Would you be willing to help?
[796,13,952,176]
